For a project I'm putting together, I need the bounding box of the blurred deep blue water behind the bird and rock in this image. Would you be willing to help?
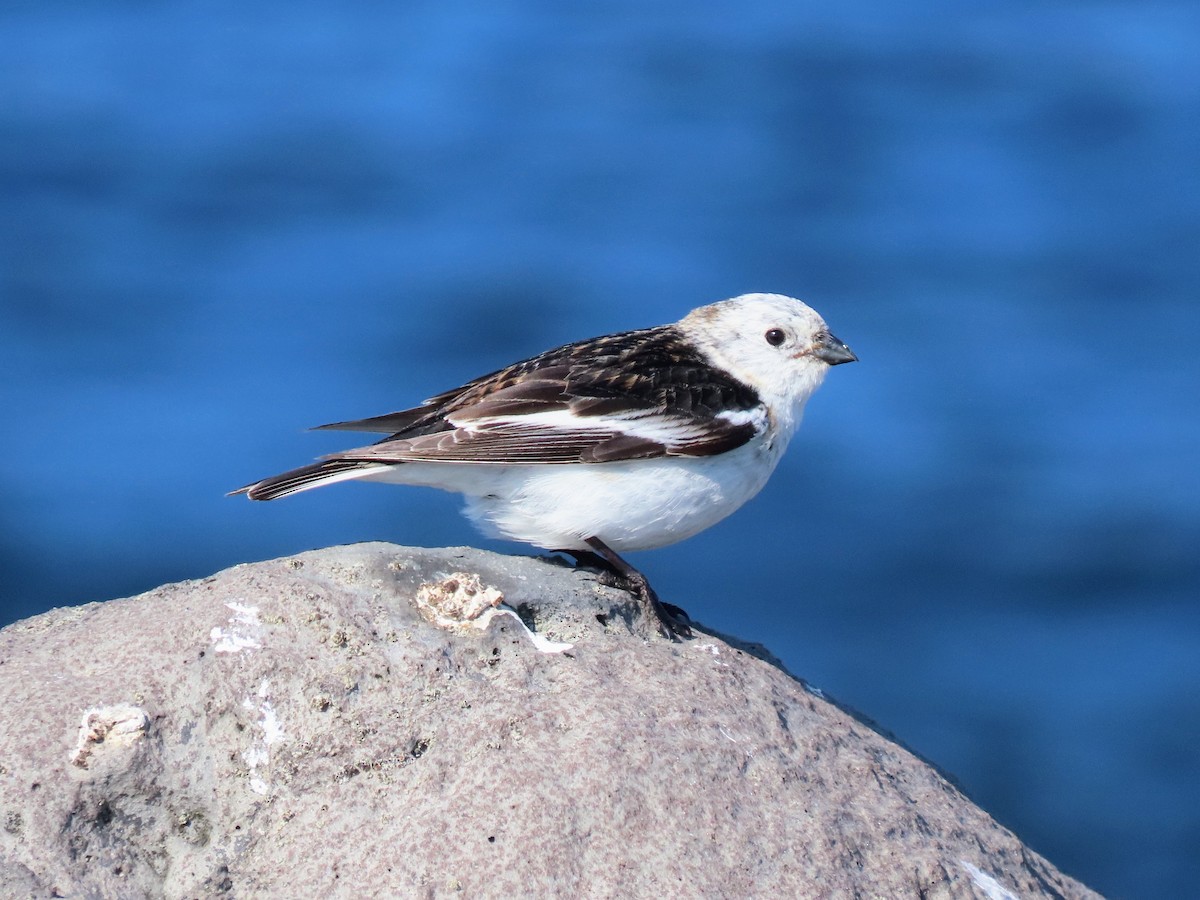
[0,0,1200,898]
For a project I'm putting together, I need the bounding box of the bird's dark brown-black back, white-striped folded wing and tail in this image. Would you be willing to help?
[235,325,767,499]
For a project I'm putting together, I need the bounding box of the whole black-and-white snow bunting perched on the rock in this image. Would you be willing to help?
[234,294,858,637]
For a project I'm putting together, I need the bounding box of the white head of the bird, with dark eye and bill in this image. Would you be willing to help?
[679,294,858,434]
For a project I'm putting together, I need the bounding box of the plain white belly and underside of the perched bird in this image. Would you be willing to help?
[372,440,782,553]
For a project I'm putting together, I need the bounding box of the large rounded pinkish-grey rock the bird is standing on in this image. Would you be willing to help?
[0,544,1096,898]
